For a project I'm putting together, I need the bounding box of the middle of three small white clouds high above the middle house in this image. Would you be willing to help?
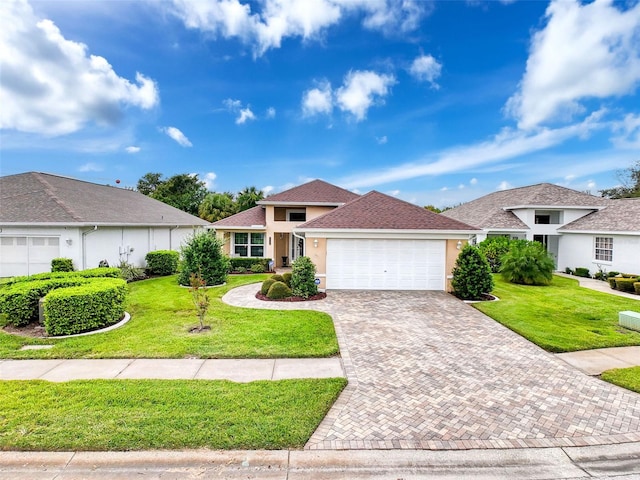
[336,70,396,121]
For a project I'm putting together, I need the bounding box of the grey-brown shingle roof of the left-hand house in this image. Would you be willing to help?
[0,172,210,226]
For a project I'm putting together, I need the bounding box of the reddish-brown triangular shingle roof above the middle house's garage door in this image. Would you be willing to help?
[298,190,475,231]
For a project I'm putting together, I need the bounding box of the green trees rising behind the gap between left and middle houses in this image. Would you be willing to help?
[136,172,264,222]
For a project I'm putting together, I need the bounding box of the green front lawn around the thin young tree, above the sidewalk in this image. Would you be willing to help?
[0,275,339,359]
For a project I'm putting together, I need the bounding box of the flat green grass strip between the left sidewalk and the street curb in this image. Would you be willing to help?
[0,378,346,451]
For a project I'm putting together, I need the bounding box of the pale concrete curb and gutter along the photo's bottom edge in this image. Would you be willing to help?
[0,443,640,480]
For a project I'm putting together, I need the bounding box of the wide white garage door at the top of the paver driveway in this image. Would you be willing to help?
[327,239,446,290]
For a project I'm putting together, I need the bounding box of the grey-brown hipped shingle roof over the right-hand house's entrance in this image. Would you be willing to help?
[442,183,611,230]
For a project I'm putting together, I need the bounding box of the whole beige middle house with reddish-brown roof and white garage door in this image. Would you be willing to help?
[213,180,479,290]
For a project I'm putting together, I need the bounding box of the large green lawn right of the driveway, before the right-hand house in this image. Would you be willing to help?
[474,275,640,352]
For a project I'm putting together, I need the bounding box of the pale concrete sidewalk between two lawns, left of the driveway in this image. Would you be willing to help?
[0,357,345,382]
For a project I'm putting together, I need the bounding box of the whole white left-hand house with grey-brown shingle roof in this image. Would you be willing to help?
[0,172,210,277]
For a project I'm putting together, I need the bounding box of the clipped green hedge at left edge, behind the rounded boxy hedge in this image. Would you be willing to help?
[0,276,89,327]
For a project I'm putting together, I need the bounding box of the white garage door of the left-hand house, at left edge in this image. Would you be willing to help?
[0,237,60,277]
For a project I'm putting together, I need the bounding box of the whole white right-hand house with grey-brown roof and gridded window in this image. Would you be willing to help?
[442,183,640,273]
